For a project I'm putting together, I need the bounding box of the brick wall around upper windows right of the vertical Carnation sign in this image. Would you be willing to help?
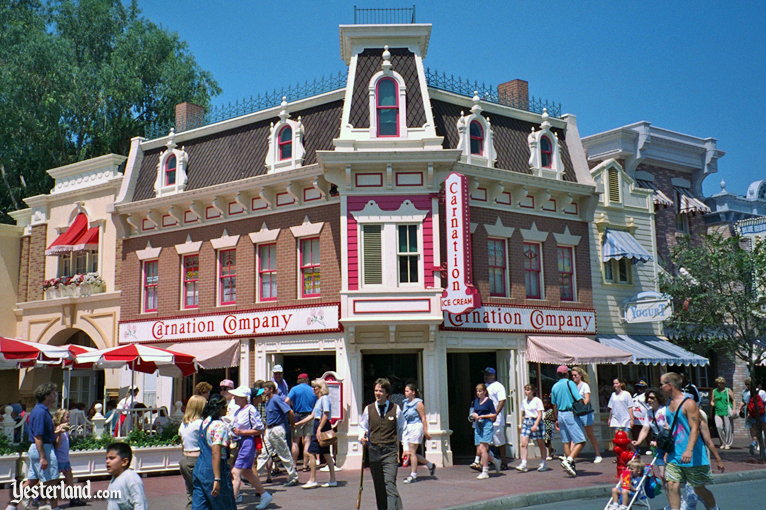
[462,207,593,308]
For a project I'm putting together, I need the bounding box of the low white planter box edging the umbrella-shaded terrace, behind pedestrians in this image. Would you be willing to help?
[19,445,181,483]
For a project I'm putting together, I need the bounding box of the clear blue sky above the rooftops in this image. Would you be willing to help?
[139,0,766,195]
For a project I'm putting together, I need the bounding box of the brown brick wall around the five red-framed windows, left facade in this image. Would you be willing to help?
[118,204,341,320]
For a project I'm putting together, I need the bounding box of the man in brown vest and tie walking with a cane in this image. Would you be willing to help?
[359,379,404,510]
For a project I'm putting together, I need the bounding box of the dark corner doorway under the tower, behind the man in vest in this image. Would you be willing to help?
[362,352,420,407]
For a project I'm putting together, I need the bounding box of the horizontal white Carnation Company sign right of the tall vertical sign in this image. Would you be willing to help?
[443,305,596,334]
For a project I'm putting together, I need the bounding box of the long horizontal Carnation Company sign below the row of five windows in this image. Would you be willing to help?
[120,305,340,343]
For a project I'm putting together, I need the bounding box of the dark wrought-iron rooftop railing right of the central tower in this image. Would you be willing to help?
[426,68,561,117]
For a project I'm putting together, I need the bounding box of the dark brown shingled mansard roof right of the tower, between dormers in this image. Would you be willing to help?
[431,99,577,182]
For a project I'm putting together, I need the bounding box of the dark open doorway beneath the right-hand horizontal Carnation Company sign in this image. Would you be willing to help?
[447,351,497,464]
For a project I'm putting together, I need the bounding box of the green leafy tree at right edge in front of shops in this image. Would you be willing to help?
[661,234,766,375]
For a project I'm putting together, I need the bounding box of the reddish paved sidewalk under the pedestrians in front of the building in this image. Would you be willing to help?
[24,448,766,510]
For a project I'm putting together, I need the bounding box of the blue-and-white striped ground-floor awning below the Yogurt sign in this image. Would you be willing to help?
[596,335,709,367]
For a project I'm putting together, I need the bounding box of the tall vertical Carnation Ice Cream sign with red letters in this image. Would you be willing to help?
[441,172,481,314]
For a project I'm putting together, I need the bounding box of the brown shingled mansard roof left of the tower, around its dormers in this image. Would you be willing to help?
[133,101,343,202]
